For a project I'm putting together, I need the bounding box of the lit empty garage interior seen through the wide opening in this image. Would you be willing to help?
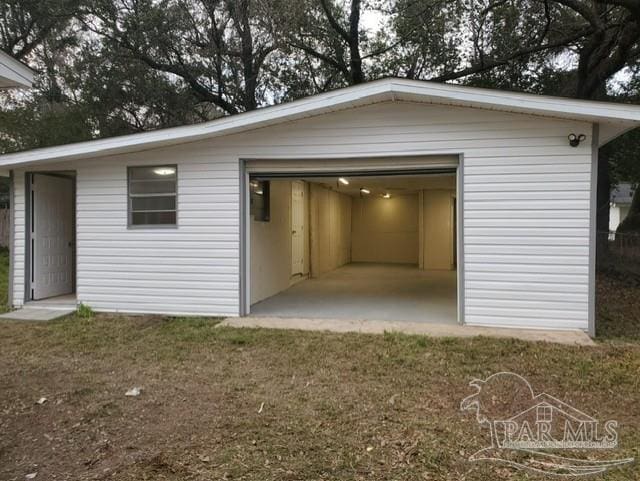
[249,170,458,324]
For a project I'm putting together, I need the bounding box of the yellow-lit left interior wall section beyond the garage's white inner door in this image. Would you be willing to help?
[309,184,352,277]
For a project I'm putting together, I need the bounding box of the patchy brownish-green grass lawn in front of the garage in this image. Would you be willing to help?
[0,255,640,481]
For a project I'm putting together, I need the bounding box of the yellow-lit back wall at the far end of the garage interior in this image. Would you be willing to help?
[352,193,419,264]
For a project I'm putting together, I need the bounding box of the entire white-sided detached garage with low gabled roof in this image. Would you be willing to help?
[0,79,640,333]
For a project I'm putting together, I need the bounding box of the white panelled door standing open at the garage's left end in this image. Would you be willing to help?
[31,174,75,300]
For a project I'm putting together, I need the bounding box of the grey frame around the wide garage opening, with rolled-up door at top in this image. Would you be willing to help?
[238,152,465,325]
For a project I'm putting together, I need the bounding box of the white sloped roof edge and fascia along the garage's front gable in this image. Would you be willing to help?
[0,78,640,168]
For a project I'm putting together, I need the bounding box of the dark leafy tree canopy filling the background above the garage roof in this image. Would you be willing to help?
[0,0,640,156]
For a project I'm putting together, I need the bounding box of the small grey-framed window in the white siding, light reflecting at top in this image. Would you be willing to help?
[127,165,178,227]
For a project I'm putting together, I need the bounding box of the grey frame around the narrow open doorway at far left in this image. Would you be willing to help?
[24,170,78,303]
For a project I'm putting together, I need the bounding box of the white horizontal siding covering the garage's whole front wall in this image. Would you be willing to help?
[14,102,591,329]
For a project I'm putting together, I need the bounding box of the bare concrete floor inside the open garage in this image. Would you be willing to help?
[250,263,458,324]
